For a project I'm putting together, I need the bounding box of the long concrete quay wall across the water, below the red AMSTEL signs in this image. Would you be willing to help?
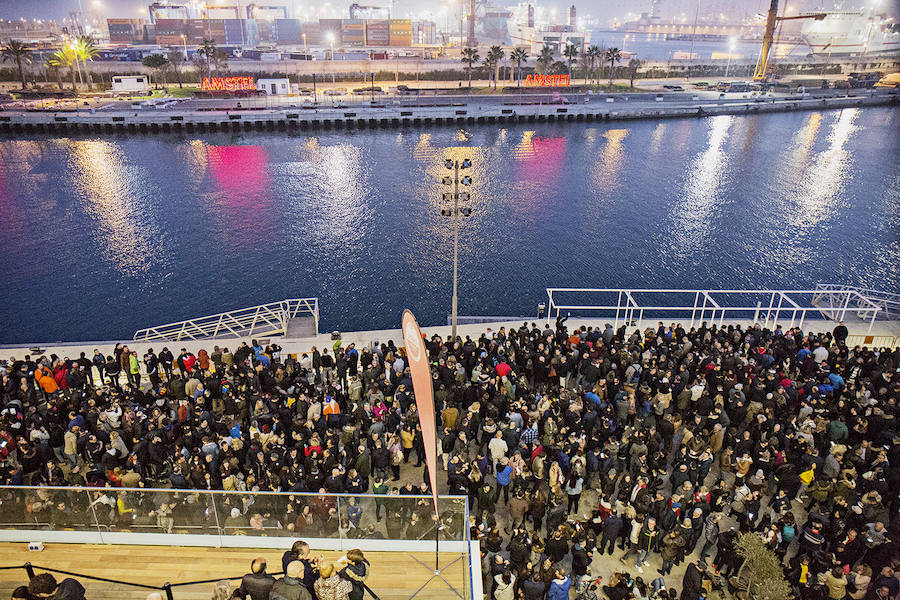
[0,94,900,134]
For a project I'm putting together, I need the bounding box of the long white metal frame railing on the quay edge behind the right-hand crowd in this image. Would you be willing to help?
[547,287,890,331]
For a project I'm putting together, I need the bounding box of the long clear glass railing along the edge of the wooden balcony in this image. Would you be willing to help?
[0,486,469,542]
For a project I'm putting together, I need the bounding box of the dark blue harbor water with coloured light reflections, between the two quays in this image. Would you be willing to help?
[0,108,900,343]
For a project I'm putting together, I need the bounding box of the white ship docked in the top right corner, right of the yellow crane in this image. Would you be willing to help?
[800,8,900,56]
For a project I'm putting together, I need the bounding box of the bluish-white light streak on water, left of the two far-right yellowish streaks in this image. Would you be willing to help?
[670,115,734,255]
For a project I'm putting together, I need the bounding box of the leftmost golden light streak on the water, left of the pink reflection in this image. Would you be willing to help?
[71,140,162,277]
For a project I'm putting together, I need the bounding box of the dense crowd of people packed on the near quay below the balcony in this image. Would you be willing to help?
[0,318,900,600]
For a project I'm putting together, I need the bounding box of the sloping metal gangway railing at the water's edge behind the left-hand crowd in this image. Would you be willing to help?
[133,298,319,342]
